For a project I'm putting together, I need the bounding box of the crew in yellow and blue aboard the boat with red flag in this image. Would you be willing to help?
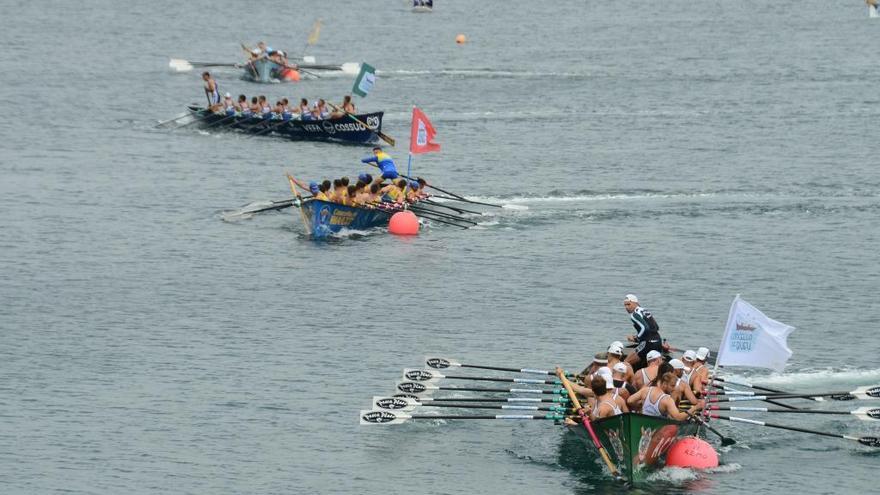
[294,146,428,206]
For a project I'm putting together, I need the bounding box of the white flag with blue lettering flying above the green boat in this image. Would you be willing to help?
[716,295,794,371]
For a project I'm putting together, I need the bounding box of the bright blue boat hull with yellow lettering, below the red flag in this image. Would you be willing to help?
[300,198,394,239]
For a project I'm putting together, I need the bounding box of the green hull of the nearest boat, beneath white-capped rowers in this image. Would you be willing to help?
[568,413,699,483]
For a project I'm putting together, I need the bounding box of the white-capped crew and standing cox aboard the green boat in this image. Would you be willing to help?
[556,294,710,421]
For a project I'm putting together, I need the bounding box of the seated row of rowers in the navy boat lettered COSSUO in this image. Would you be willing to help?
[214,93,357,120]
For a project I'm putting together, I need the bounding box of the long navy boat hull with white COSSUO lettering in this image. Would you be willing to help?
[188,105,384,144]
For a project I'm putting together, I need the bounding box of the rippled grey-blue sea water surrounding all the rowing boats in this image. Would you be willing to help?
[0,0,880,495]
